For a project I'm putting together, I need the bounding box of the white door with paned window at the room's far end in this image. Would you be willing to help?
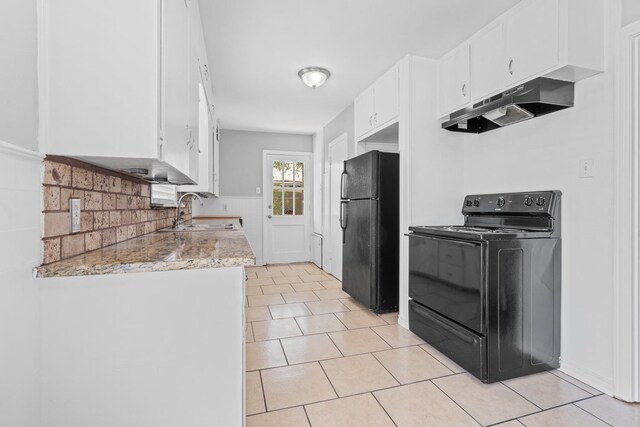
[263,152,312,264]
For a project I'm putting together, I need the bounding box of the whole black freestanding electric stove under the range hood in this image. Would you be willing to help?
[409,191,561,383]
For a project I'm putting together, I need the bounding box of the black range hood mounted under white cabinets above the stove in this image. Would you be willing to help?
[442,77,574,133]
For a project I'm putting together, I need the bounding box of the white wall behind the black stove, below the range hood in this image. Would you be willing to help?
[464,70,614,392]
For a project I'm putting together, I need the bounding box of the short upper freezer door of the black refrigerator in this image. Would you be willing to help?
[342,151,379,199]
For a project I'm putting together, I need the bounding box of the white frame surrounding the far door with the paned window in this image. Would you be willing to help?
[262,150,313,265]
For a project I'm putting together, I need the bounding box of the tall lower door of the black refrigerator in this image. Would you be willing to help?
[342,199,378,310]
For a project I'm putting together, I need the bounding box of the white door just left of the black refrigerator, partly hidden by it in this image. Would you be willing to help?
[329,134,347,280]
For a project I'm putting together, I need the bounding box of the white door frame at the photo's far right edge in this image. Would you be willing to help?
[612,22,640,402]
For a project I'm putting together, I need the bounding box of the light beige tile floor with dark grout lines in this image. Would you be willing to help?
[246,263,640,427]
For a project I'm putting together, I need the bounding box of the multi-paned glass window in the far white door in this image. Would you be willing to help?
[273,160,304,215]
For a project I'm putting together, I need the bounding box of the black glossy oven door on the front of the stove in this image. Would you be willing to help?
[409,233,485,334]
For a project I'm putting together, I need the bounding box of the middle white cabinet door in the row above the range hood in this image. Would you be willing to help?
[470,23,507,100]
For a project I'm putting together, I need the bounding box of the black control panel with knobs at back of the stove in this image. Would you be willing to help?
[462,191,561,216]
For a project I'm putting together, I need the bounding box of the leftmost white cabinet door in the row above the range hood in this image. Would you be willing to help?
[439,44,471,115]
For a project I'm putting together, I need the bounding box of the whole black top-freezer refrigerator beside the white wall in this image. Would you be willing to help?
[340,151,400,313]
